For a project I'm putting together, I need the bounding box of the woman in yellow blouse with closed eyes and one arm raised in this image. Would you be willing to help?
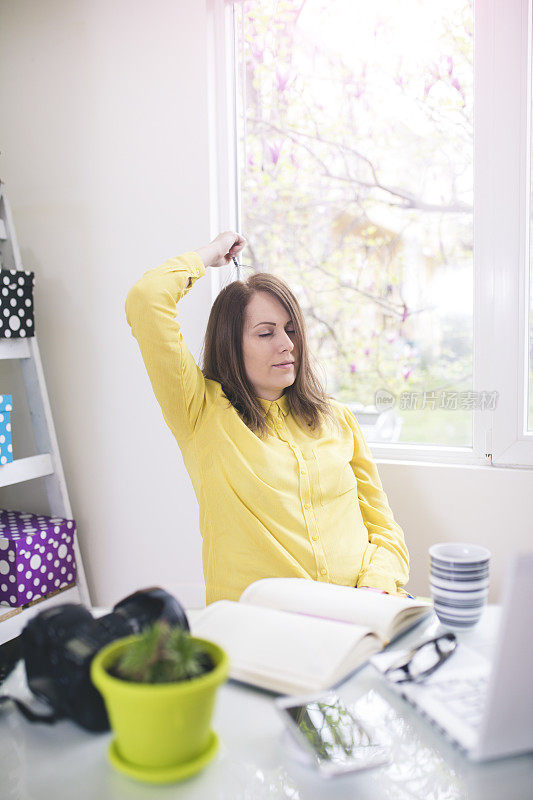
[126,231,409,603]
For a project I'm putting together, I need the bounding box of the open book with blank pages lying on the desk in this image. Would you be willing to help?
[191,578,433,694]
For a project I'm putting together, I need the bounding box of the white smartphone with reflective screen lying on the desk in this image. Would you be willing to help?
[274,692,391,778]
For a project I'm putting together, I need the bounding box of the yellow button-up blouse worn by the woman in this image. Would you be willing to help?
[125,251,409,603]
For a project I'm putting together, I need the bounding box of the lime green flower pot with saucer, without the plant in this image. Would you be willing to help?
[91,636,229,782]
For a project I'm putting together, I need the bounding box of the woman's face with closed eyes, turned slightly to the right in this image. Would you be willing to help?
[242,292,298,400]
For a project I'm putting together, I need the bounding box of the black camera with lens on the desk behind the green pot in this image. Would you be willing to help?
[1,588,189,731]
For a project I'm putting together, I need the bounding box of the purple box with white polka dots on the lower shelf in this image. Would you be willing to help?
[0,509,76,607]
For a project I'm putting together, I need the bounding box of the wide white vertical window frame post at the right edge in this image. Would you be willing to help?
[474,0,533,468]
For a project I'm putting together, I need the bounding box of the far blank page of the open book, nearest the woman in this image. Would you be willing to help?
[239,578,431,643]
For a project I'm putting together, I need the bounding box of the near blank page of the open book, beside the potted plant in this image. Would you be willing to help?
[192,600,380,691]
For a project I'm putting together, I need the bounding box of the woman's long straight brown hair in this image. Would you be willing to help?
[202,272,338,438]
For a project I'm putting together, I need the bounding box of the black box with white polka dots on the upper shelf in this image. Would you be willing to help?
[0,269,35,339]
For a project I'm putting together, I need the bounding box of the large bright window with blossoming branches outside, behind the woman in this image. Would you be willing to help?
[209,0,533,466]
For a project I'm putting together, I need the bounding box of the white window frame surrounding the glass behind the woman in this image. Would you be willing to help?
[207,0,533,469]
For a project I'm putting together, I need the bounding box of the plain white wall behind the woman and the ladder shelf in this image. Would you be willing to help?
[0,0,533,604]
